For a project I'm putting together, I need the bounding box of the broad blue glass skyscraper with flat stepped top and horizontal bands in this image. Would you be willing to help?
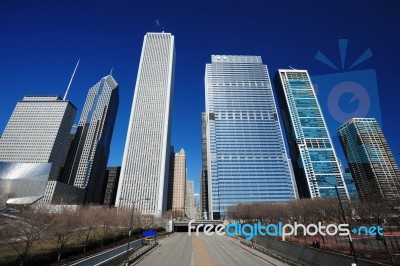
[205,55,295,219]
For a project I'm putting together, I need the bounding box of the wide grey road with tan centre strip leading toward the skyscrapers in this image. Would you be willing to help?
[135,233,287,266]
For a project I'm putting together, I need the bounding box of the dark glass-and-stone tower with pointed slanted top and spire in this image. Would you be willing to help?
[61,75,119,203]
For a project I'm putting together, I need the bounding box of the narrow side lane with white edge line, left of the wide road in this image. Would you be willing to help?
[70,239,142,266]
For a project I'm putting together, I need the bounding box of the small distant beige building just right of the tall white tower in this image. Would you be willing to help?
[168,149,186,216]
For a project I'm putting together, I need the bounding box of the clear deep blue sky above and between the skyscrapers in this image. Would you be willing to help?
[0,0,400,191]
